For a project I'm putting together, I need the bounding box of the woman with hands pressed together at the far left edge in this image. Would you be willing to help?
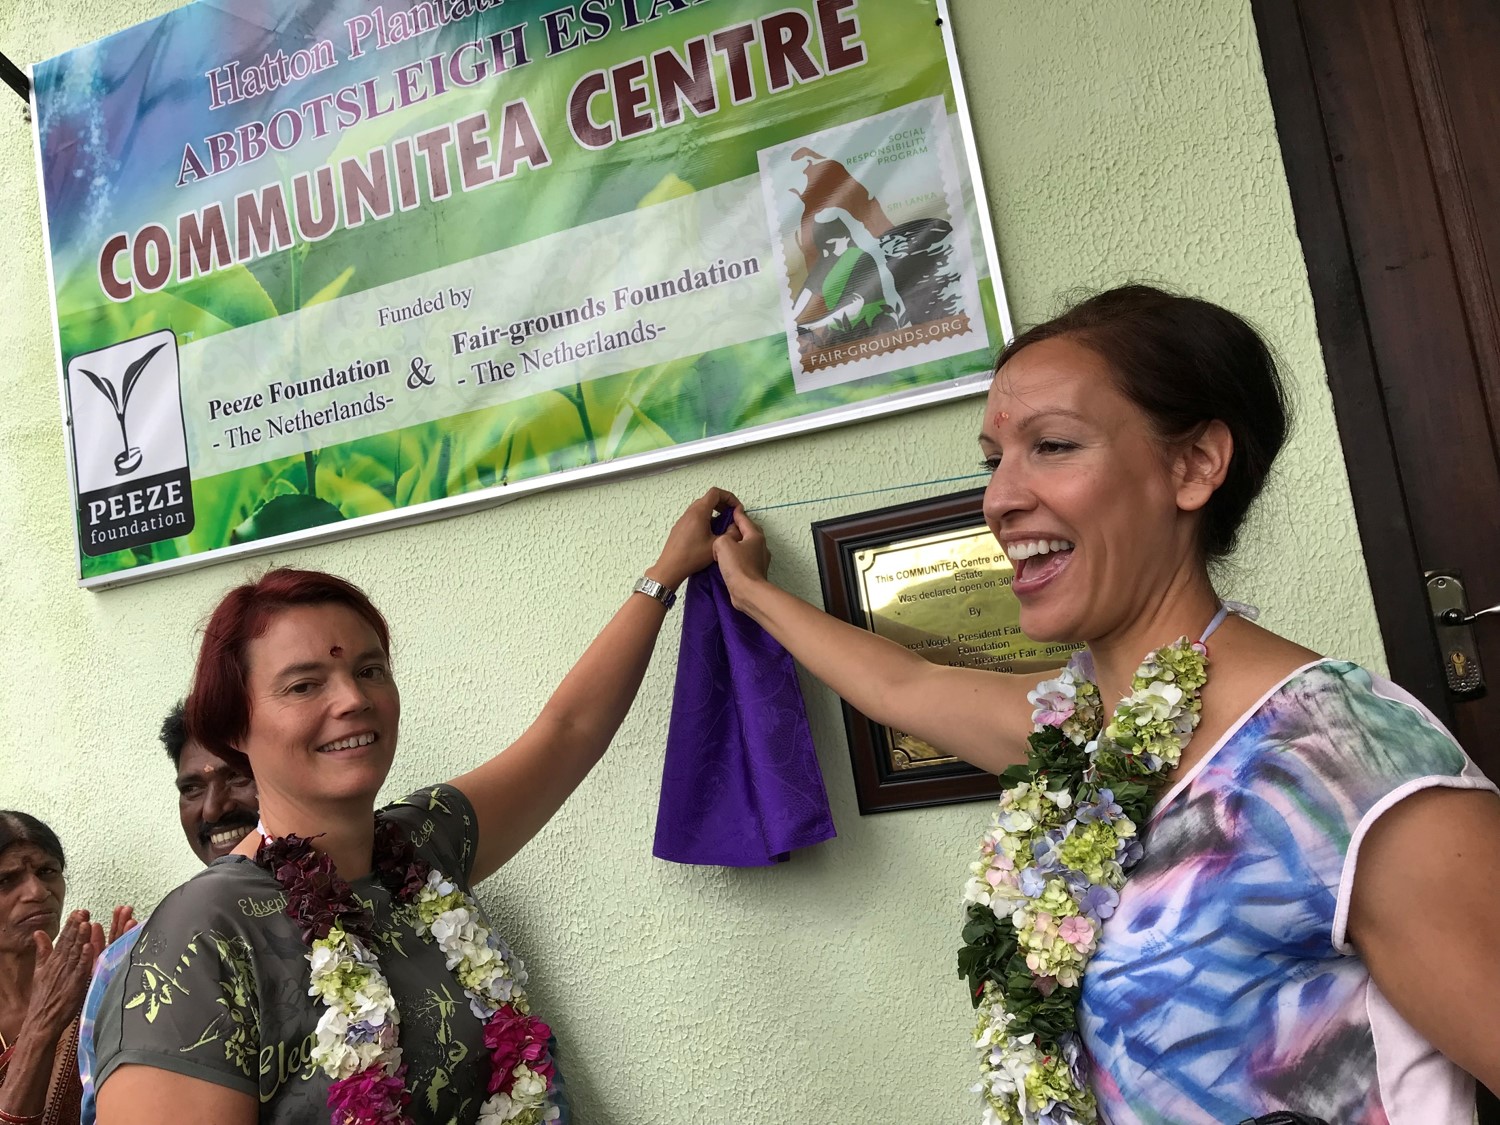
[0,812,104,1125]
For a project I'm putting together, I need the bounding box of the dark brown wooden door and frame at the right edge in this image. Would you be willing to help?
[1253,0,1500,1125]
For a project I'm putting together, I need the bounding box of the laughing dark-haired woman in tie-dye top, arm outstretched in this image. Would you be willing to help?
[714,285,1500,1125]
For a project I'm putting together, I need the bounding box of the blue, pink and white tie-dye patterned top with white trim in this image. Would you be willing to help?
[1080,660,1496,1125]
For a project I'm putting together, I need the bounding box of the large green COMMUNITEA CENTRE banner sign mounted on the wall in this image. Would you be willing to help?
[33,0,1010,585]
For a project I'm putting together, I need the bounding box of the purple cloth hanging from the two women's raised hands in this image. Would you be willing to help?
[653,516,836,867]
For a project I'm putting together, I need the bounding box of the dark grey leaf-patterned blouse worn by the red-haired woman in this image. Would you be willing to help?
[95,786,489,1125]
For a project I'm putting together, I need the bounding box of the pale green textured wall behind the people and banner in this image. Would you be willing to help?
[0,0,1382,1125]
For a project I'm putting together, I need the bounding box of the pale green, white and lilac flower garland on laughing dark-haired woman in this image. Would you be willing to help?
[959,638,1208,1125]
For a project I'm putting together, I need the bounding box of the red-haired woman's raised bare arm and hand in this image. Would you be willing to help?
[453,489,738,882]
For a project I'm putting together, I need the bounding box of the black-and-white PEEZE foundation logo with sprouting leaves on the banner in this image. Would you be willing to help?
[66,330,194,555]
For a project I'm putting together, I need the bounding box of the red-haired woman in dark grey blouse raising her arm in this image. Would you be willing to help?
[96,489,737,1125]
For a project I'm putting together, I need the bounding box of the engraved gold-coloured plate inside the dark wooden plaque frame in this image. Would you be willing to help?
[854,524,1083,771]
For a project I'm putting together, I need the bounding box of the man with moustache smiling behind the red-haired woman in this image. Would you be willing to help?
[78,702,260,1125]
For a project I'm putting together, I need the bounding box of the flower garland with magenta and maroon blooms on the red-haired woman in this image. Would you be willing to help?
[255,818,561,1125]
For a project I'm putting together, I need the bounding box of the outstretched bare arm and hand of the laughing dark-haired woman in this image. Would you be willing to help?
[714,509,1040,774]
